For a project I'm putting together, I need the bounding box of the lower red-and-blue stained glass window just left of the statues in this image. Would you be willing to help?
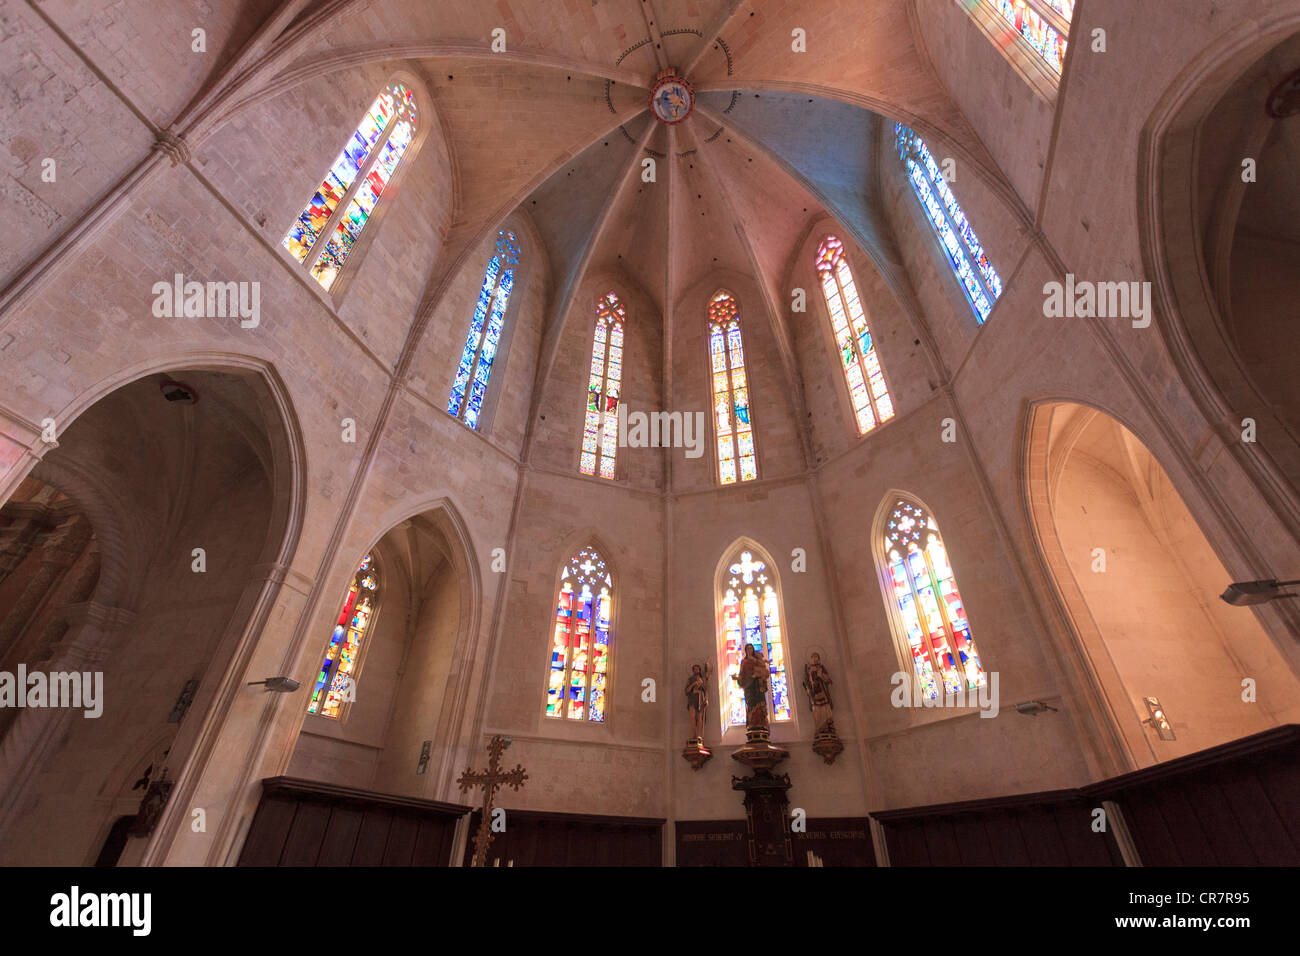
[546,548,614,723]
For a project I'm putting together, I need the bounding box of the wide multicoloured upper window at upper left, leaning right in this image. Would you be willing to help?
[280,83,416,290]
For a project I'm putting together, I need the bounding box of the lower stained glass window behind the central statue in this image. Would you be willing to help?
[714,537,794,734]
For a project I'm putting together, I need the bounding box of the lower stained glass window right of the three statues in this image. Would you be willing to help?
[880,498,988,700]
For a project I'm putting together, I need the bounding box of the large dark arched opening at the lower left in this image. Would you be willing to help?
[0,367,295,865]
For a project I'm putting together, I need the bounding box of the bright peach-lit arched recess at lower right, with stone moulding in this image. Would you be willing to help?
[1021,399,1296,773]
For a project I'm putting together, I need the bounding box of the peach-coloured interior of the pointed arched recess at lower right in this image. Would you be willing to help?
[1026,402,1300,766]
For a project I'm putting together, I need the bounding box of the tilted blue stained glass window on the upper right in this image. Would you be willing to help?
[894,124,1002,324]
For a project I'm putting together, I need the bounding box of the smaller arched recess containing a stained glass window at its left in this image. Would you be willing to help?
[286,505,475,799]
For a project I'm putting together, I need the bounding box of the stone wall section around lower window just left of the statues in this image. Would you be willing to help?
[486,481,680,817]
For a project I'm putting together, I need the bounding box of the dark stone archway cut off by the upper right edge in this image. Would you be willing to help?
[1138,10,1300,541]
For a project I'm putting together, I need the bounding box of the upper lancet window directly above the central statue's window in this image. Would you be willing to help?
[709,293,758,485]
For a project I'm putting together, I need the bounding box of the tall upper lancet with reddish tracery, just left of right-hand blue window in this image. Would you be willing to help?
[816,235,893,434]
